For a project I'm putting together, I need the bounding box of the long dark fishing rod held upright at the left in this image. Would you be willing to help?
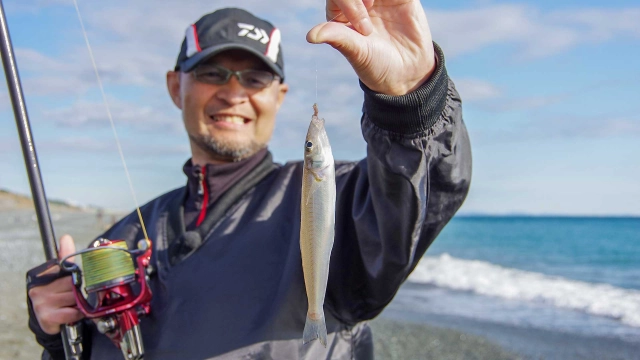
[0,0,82,360]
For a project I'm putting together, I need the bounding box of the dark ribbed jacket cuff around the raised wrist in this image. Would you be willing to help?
[360,42,449,134]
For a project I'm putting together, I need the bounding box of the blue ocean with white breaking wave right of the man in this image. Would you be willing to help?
[390,216,640,358]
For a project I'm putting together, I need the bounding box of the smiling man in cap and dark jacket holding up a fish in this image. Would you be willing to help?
[29,0,471,359]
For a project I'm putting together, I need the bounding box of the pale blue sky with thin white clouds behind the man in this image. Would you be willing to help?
[0,0,640,216]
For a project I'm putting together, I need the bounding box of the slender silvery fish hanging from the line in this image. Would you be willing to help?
[300,104,336,347]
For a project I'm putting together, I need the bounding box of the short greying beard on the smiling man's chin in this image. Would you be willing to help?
[189,134,266,162]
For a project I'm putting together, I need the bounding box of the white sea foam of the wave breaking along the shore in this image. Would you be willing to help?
[409,254,640,327]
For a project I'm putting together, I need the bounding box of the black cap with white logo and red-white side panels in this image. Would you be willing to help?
[175,8,284,79]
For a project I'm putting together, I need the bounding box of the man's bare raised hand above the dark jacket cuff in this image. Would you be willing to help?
[307,0,435,95]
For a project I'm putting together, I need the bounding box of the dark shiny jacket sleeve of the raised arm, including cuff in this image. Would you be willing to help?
[325,44,471,324]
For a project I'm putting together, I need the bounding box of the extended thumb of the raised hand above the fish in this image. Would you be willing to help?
[307,22,366,65]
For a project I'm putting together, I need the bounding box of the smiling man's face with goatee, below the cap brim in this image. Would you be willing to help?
[167,50,288,163]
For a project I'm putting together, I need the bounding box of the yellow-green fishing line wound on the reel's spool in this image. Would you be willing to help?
[81,241,135,291]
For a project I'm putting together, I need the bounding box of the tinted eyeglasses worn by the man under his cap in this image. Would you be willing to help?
[192,65,280,89]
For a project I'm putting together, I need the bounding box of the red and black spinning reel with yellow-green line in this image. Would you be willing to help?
[60,239,151,360]
